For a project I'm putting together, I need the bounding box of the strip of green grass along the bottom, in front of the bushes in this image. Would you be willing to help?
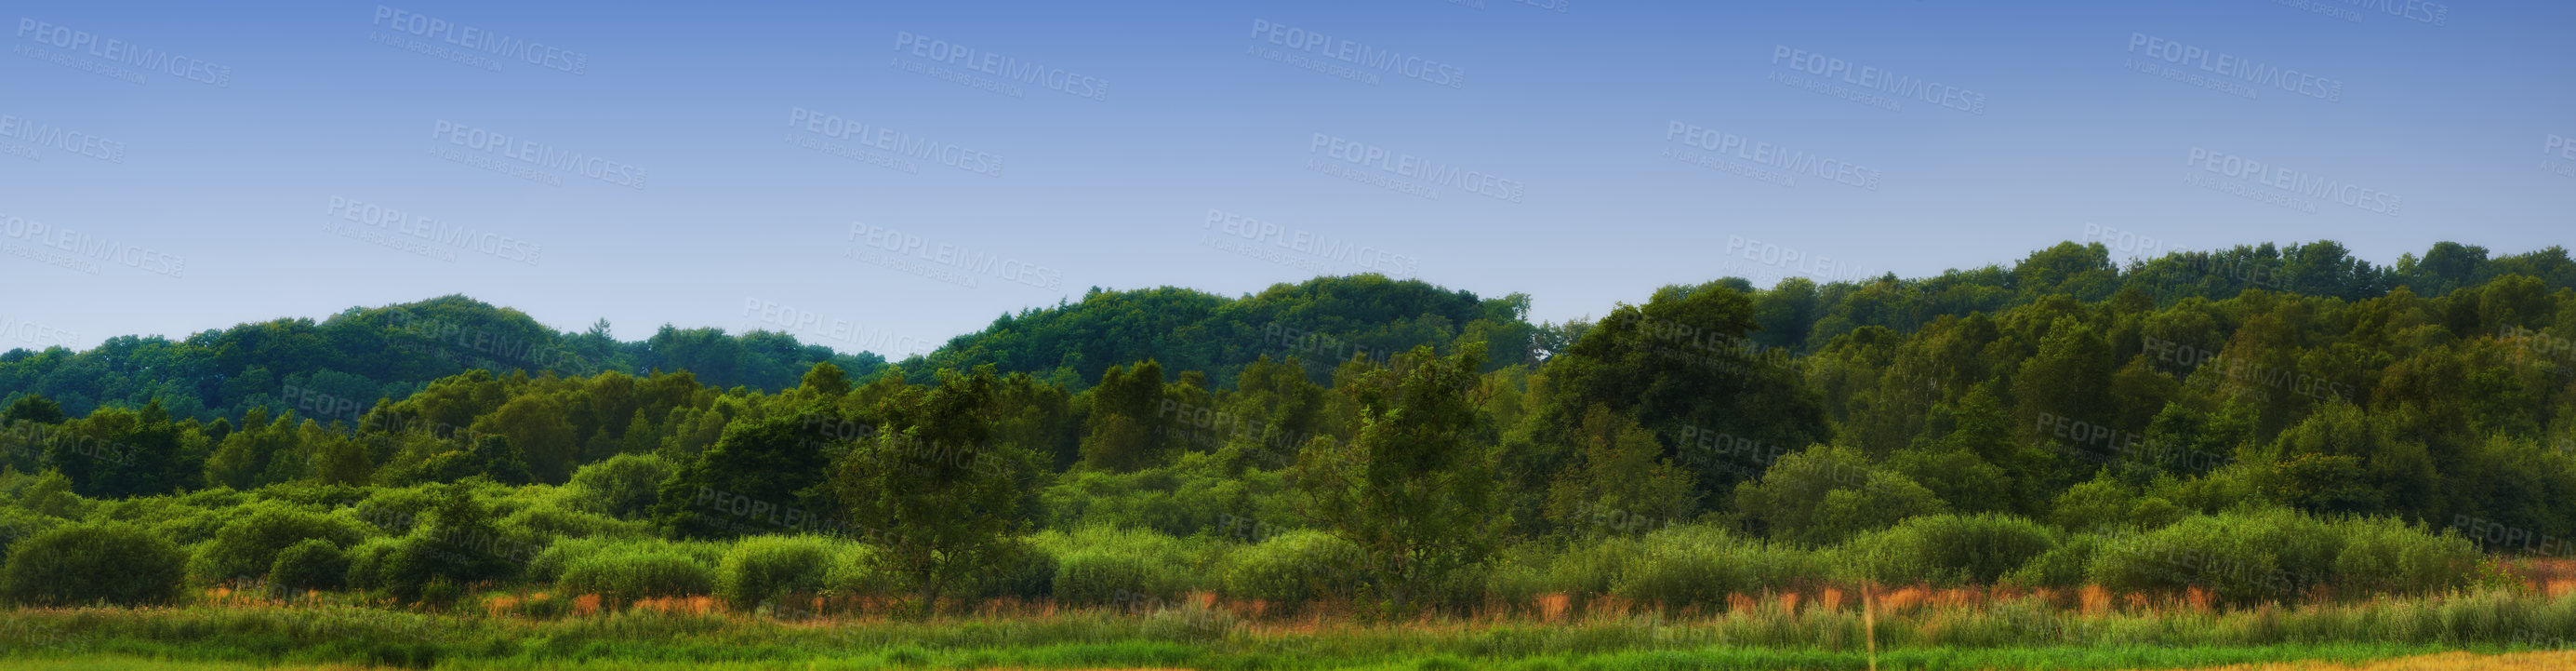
[0,594,2576,671]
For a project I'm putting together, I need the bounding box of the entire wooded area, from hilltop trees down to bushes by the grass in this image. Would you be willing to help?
[0,240,2576,661]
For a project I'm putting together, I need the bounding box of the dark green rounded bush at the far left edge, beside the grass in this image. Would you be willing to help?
[0,521,188,607]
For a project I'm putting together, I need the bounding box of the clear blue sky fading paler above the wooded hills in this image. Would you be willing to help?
[0,0,2576,358]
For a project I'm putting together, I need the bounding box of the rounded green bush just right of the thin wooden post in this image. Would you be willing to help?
[1834,514,2058,585]
